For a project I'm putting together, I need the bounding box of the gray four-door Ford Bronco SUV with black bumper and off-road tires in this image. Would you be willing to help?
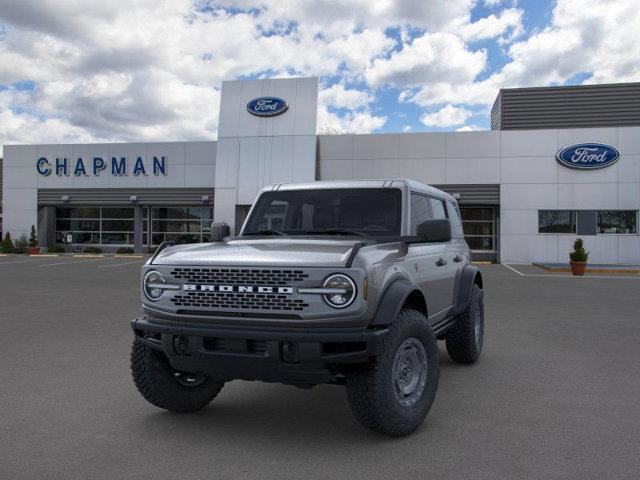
[131,180,484,435]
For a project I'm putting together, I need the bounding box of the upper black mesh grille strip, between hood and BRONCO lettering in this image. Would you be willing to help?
[171,267,309,286]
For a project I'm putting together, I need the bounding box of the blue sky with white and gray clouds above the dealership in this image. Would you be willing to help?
[0,0,640,154]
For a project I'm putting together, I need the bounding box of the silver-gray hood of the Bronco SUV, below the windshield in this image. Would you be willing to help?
[153,238,361,267]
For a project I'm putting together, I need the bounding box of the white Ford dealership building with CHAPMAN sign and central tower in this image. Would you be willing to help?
[0,78,640,264]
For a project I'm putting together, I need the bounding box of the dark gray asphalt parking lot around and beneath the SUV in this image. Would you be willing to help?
[0,256,640,480]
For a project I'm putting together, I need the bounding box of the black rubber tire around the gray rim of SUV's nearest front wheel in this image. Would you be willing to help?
[346,309,439,436]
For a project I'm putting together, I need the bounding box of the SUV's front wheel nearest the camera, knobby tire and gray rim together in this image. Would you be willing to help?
[346,309,439,436]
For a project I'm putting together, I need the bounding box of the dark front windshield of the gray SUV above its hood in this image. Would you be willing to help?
[243,188,402,236]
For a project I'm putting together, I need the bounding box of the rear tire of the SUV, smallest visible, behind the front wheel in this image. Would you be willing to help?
[445,284,484,363]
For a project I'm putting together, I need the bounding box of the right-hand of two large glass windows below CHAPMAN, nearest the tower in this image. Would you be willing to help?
[151,207,213,245]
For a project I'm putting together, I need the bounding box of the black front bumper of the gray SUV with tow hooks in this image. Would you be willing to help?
[131,318,388,386]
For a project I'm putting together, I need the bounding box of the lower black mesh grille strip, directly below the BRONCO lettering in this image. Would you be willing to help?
[171,292,309,311]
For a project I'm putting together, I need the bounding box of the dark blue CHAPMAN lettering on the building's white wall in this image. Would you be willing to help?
[36,157,167,177]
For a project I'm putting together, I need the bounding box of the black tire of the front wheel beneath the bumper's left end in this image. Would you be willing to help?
[131,340,224,413]
